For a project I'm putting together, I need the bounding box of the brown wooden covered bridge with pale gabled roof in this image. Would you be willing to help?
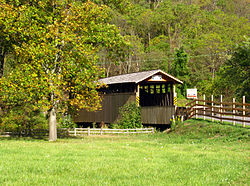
[75,70,183,125]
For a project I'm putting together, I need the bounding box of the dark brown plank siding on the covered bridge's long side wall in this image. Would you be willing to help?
[74,93,136,123]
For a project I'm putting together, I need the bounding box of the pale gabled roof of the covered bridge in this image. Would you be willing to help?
[99,70,183,85]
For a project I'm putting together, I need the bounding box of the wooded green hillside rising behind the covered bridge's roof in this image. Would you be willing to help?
[97,0,250,100]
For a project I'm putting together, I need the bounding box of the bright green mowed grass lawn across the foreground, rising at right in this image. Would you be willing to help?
[0,120,250,185]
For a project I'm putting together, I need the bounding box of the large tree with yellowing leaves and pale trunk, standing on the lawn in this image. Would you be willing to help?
[0,0,125,141]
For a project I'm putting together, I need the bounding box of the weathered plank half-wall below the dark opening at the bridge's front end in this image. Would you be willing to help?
[141,106,175,124]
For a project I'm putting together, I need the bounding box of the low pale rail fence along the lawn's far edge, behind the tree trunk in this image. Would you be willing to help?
[0,128,155,137]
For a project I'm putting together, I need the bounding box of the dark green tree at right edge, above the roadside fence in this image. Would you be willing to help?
[213,38,250,102]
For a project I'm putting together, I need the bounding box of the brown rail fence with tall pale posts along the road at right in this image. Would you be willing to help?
[186,95,250,127]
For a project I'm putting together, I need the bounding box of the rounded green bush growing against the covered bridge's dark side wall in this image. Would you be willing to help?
[114,102,142,129]
